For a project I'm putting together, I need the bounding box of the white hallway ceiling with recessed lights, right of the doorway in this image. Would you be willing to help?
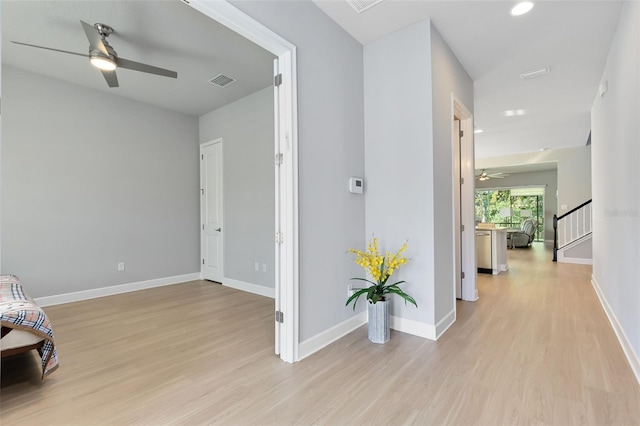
[314,0,621,158]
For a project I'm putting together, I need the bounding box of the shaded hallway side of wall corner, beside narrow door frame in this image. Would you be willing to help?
[431,24,473,322]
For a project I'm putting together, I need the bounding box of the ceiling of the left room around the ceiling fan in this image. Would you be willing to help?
[2,0,274,116]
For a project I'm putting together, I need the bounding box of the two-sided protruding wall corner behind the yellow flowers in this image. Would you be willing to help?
[364,20,473,336]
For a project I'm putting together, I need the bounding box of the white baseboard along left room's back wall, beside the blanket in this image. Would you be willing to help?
[35,272,200,306]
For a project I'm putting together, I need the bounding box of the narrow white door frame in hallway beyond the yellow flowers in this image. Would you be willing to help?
[451,93,478,306]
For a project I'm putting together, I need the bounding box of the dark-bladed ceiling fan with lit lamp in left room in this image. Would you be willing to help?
[12,21,178,87]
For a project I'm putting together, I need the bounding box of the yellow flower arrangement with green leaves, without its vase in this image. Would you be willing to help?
[346,237,418,310]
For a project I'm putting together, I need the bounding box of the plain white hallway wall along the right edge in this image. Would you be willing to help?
[591,2,640,381]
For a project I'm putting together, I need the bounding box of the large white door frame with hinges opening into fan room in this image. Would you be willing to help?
[182,0,300,363]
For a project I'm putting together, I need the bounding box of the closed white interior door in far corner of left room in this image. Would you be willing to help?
[200,139,224,282]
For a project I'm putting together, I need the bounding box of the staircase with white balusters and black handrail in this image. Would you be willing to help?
[553,200,593,265]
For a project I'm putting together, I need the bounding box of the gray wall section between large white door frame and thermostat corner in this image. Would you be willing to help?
[232,1,365,341]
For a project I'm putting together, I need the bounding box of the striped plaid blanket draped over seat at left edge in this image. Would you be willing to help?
[0,275,58,378]
